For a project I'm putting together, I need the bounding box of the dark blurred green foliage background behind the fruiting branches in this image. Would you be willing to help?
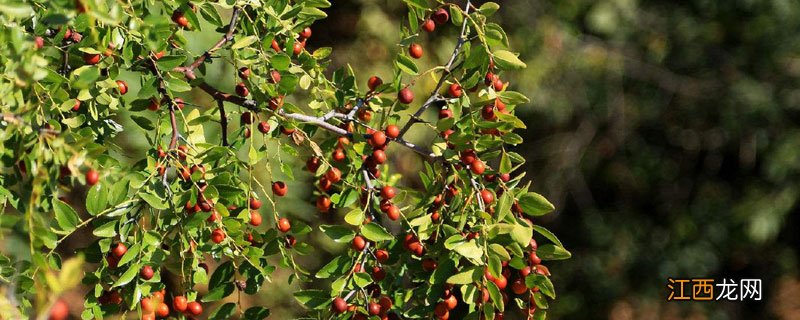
[37,0,800,319]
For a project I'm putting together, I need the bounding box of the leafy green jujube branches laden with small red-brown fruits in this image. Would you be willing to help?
[0,0,570,319]
